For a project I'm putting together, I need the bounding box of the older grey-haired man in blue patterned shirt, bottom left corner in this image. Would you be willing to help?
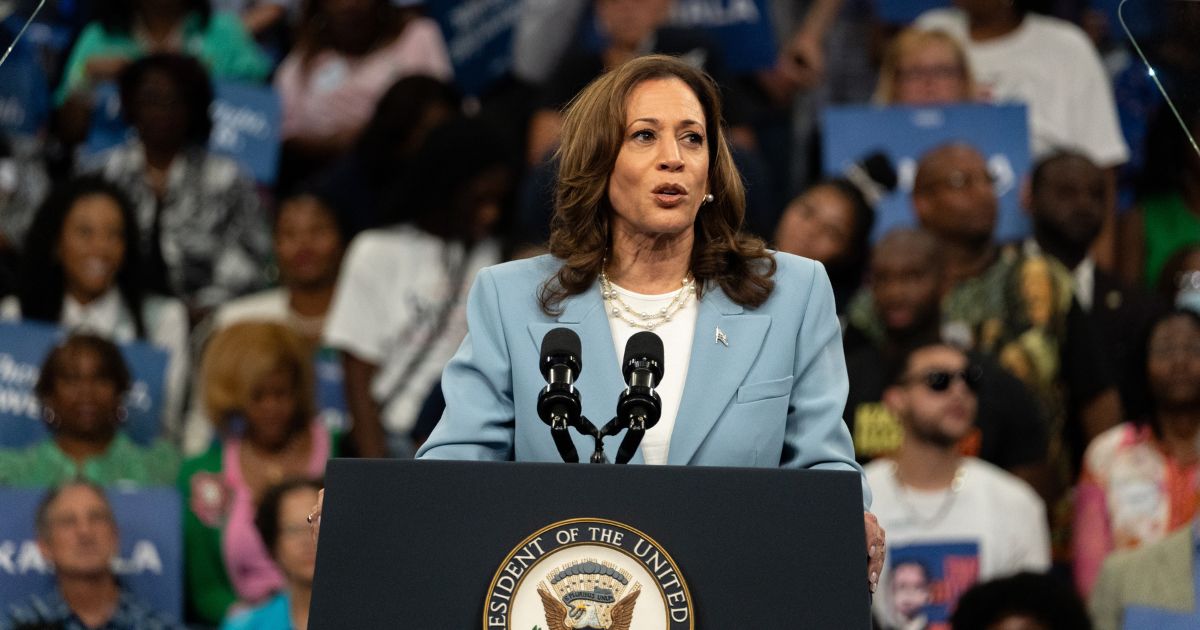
[0,481,182,630]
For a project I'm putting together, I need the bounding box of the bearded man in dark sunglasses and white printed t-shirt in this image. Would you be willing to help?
[866,343,1050,628]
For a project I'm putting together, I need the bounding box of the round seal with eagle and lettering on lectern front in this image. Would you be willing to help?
[484,518,695,630]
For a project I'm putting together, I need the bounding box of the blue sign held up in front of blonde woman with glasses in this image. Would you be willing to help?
[822,104,1031,242]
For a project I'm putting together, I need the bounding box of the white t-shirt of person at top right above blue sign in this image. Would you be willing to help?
[917,8,1129,167]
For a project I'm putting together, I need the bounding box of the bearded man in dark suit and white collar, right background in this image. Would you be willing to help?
[1025,151,1157,415]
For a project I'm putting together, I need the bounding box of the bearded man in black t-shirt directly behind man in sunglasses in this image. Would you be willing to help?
[844,228,1048,487]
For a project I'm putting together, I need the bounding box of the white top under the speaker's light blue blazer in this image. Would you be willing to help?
[605,284,700,464]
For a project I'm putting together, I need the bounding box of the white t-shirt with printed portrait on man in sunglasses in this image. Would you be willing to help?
[865,457,1050,628]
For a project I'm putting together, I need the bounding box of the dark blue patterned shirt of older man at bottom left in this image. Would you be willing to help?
[0,589,184,630]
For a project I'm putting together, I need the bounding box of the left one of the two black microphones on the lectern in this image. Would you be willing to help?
[538,328,583,463]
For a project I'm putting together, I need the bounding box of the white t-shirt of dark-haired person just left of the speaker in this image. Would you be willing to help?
[324,226,500,433]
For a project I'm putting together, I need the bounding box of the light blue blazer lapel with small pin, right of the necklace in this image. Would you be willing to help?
[667,287,770,466]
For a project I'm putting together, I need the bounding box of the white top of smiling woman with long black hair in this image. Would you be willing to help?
[0,287,188,440]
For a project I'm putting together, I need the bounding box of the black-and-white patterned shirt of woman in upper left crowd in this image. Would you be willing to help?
[83,138,271,307]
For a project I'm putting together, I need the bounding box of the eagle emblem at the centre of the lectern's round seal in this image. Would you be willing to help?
[538,560,642,630]
